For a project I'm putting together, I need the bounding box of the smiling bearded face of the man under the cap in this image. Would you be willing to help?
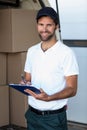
[37,16,57,41]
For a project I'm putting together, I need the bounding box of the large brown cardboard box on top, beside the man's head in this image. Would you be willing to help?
[0,8,40,52]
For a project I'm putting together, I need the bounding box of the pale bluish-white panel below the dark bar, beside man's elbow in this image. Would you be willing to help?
[67,47,87,124]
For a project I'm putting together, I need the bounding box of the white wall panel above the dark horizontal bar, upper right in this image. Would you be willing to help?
[49,0,87,40]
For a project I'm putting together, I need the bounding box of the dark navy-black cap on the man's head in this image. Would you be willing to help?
[36,7,59,24]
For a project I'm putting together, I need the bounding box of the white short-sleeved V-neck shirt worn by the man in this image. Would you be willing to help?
[24,41,79,110]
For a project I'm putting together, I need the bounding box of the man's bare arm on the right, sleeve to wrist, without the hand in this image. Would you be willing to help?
[48,75,77,100]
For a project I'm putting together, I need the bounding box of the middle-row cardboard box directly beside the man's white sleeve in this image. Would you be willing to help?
[7,52,26,83]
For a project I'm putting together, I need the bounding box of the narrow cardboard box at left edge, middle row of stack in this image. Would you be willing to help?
[0,53,6,85]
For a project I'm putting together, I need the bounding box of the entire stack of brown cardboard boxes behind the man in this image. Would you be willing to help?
[0,9,40,127]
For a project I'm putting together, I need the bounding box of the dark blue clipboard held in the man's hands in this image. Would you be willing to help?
[9,84,40,96]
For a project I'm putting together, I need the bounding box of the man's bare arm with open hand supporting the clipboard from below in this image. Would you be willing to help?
[25,75,78,101]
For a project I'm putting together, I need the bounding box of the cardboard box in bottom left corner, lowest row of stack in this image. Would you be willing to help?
[0,85,9,127]
